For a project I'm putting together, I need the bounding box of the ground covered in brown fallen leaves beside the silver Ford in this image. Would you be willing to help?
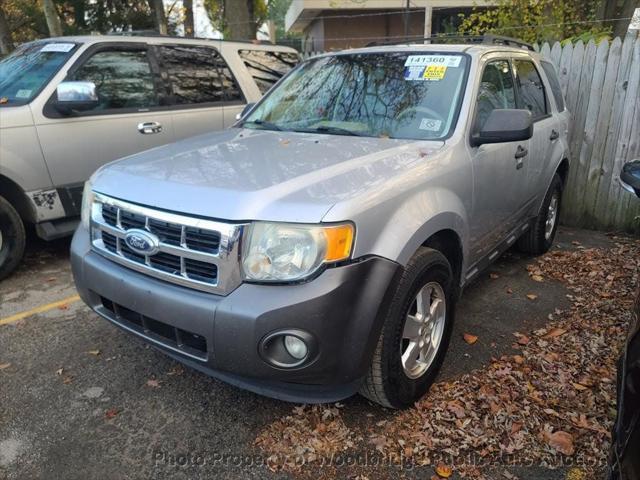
[256,237,640,479]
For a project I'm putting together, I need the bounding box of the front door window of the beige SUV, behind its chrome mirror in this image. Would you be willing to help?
[69,50,159,112]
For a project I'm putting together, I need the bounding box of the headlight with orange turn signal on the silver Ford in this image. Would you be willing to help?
[242,222,354,282]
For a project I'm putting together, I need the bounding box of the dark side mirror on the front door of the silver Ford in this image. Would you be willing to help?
[471,109,533,147]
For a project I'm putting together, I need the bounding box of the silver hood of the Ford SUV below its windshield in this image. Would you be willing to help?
[93,128,443,223]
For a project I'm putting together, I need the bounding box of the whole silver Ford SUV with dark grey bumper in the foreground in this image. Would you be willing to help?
[71,35,569,408]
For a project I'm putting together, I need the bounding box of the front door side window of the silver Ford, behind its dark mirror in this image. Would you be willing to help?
[475,60,517,131]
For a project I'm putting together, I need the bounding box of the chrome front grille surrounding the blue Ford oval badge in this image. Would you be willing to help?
[91,194,244,295]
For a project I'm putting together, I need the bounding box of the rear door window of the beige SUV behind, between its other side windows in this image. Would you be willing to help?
[159,46,244,105]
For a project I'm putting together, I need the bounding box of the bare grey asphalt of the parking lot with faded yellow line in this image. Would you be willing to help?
[0,229,609,479]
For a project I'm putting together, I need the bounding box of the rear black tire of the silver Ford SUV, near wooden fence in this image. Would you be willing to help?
[517,173,563,255]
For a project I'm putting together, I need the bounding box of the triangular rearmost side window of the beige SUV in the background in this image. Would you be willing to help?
[238,50,300,95]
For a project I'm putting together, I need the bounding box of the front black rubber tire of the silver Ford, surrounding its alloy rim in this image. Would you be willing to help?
[360,247,456,408]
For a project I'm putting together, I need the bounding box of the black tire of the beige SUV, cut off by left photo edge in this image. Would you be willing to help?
[0,197,26,280]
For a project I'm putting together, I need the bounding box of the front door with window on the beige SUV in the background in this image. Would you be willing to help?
[34,44,173,186]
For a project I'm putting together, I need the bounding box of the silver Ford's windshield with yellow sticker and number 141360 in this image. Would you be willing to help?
[242,53,467,140]
